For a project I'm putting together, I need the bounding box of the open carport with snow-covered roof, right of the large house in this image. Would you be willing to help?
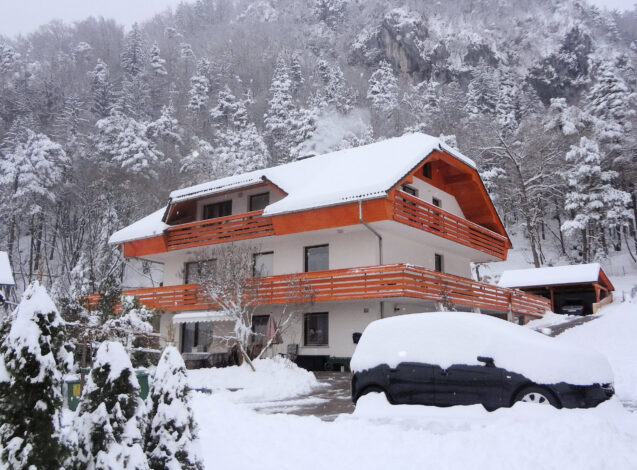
[498,263,615,315]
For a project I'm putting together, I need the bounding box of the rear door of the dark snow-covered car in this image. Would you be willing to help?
[389,362,437,405]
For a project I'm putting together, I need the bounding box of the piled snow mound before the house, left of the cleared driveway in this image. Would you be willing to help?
[188,357,319,402]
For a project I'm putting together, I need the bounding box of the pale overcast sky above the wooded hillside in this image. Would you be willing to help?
[0,0,637,36]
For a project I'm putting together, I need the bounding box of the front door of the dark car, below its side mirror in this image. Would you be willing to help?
[434,364,503,408]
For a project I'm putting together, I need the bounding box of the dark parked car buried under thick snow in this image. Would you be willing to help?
[350,312,614,410]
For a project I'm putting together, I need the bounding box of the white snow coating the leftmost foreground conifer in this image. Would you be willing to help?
[0,282,62,383]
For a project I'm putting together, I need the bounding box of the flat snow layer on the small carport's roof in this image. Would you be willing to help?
[498,263,602,287]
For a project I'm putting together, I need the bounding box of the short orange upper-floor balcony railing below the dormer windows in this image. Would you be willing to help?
[165,211,274,250]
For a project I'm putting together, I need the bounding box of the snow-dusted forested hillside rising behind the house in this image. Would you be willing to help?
[0,0,637,297]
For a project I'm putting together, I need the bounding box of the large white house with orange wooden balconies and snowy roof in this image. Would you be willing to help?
[91,134,549,368]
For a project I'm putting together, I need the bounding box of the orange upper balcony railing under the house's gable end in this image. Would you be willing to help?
[394,192,507,259]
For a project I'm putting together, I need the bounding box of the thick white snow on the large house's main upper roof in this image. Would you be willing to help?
[170,133,476,215]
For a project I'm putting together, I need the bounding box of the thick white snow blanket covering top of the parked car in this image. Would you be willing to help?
[350,312,613,385]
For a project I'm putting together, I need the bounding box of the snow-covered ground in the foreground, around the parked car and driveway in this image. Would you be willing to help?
[190,296,637,470]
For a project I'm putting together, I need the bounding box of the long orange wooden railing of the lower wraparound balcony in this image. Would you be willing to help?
[88,264,551,317]
